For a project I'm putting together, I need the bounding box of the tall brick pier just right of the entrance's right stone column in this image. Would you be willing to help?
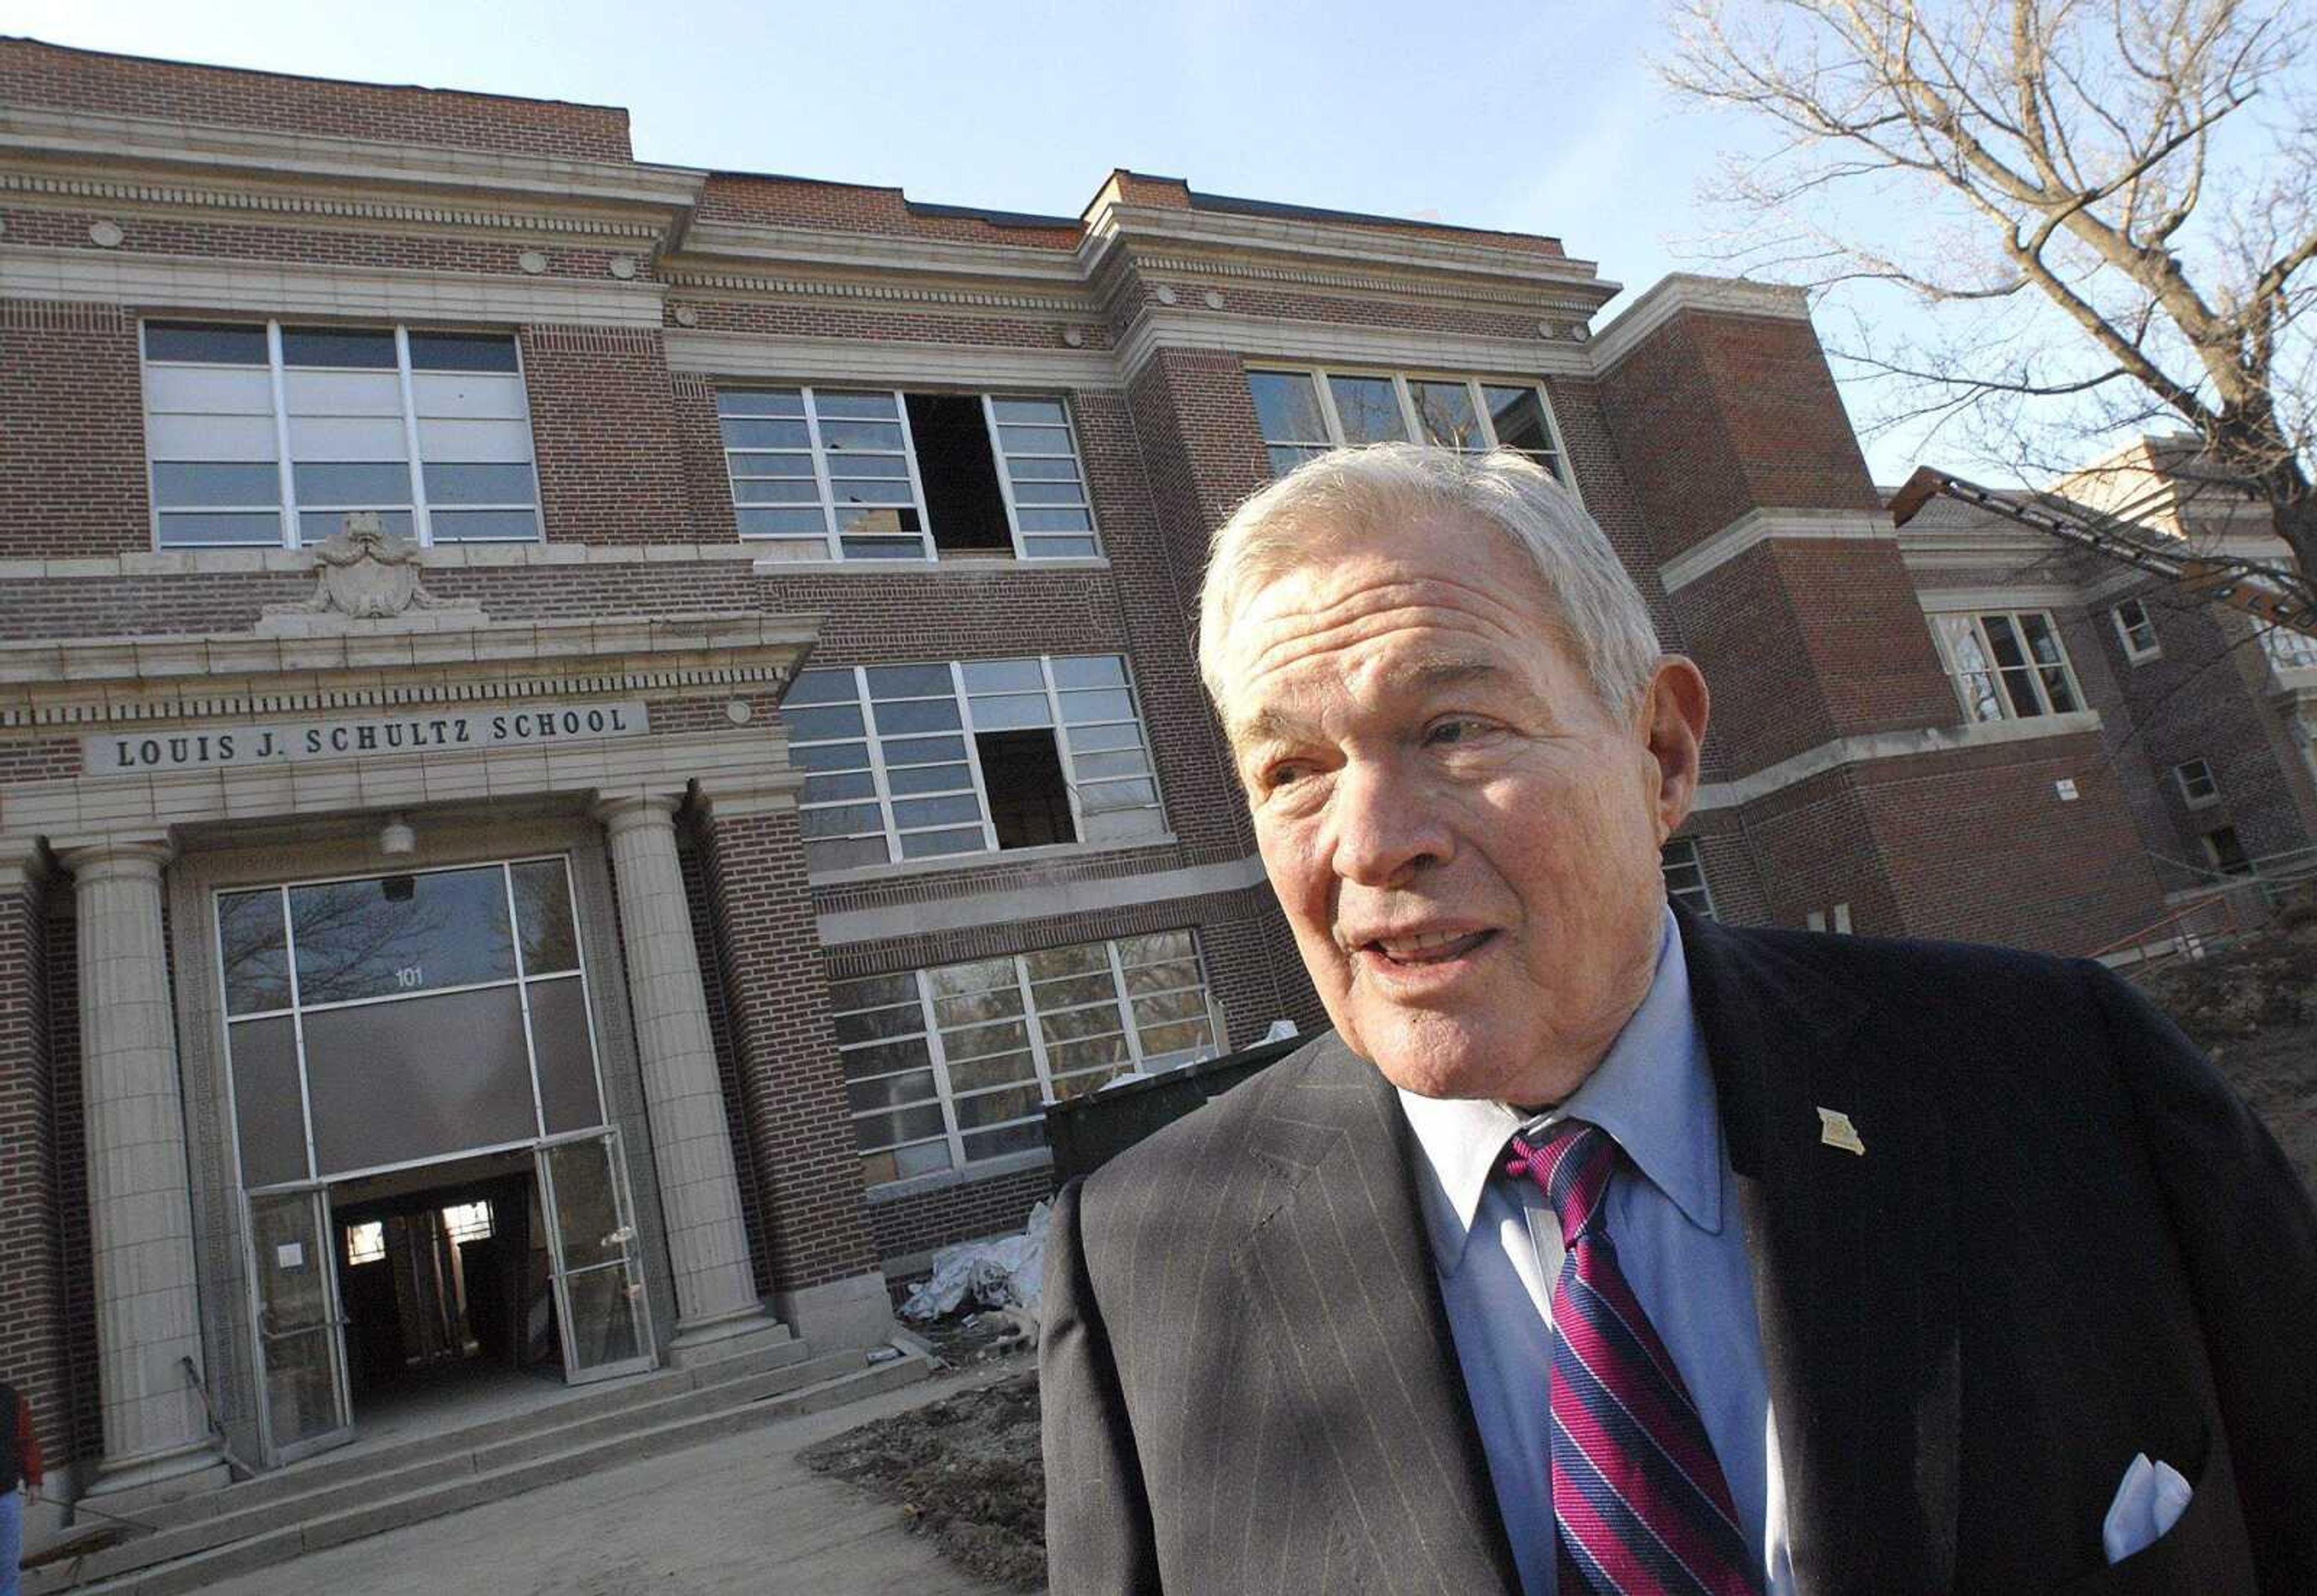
[702,811,876,1290]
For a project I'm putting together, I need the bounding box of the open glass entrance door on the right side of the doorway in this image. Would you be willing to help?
[538,1130,653,1385]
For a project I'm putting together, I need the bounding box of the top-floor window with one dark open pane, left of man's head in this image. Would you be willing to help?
[716,387,1101,561]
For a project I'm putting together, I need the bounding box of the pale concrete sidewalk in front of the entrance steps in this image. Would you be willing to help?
[209,1362,1017,1596]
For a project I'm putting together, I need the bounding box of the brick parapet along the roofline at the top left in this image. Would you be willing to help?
[0,39,630,160]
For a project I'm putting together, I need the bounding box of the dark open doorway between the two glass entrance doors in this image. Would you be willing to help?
[331,1154,563,1422]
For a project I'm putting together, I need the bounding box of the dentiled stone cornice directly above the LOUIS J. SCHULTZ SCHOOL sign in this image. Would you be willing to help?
[0,611,820,727]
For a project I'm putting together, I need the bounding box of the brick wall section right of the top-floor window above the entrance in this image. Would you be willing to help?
[521,326,698,544]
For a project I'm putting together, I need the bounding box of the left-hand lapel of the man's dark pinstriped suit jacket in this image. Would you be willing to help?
[1239,1038,1520,1596]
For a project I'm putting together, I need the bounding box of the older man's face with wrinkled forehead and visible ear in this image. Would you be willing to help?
[1225,517,1705,1105]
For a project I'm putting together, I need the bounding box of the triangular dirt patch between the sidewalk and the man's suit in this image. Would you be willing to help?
[799,1355,1045,1591]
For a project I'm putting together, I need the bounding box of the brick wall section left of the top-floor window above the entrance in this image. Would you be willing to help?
[0,301,153,561]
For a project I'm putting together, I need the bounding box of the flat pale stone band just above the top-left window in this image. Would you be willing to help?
[0,246,665,326]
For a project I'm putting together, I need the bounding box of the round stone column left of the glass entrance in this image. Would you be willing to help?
[58,836,218,1494]
